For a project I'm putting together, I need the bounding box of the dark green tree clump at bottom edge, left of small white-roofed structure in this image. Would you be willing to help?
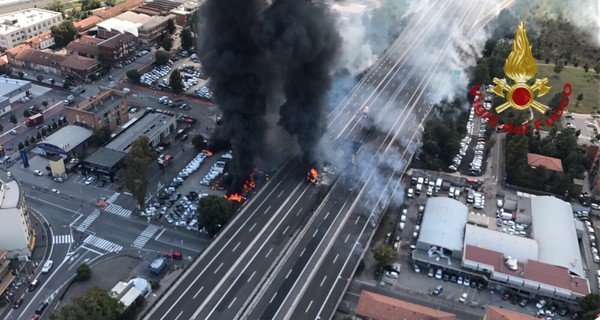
[50,287,124,320]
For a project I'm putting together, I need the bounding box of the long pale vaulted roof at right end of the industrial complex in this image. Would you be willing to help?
[531,196,584,277]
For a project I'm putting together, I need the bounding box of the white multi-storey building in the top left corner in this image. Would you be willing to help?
[0,8,62,50]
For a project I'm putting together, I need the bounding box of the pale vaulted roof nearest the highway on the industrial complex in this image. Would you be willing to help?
[418,197,468,251]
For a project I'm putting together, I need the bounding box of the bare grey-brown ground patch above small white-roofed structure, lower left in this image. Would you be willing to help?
[62,256,142,304]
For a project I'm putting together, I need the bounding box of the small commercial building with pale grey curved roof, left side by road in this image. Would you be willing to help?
[35,125,93,159]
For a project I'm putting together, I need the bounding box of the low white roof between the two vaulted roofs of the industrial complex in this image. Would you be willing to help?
[465,224,538,262]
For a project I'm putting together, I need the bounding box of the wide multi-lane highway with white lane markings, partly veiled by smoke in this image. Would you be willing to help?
[145,2,508,320]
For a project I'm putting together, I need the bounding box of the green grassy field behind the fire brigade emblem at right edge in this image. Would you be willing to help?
[536,65,600,114]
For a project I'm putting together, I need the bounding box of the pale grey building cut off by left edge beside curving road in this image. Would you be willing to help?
[0,180,35,259]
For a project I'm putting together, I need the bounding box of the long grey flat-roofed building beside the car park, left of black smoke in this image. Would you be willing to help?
[104,110,177,153]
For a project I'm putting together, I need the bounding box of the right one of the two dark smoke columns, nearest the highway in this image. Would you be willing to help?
[260,0,342,165]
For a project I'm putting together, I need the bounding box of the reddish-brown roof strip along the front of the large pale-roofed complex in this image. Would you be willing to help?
[463,245,590,296]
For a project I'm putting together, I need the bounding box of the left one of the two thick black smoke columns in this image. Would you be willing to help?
[198,0,272,192]
